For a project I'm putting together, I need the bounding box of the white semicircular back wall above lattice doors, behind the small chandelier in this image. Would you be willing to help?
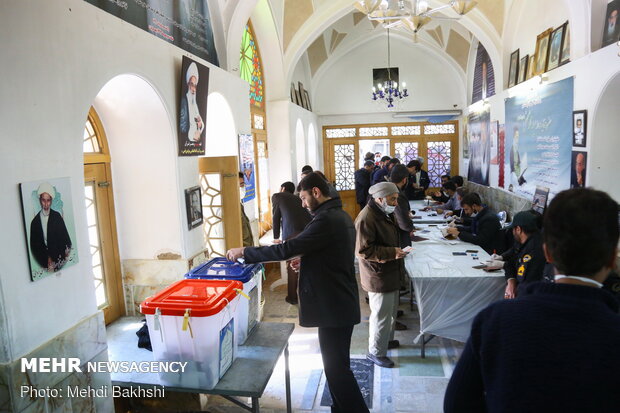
[313,37,466,116]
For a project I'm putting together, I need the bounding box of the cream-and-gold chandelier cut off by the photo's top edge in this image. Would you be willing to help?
[354,0,477,36]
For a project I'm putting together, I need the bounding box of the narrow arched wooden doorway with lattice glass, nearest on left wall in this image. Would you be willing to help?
[83,108,125,324]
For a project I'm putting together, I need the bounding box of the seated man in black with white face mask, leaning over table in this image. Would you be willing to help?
[448,193,501,254]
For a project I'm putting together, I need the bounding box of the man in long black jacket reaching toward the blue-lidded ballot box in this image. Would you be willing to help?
[226,172,368,413]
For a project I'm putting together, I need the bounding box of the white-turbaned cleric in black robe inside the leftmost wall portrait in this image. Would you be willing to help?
[30,182,72,272]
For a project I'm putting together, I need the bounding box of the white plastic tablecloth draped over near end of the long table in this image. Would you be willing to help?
[405,226,505,342]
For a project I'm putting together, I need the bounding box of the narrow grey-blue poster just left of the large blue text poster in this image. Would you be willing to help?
[467,107,491,186]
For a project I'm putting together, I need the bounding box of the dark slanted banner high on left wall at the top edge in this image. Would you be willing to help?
[85,0,219,66]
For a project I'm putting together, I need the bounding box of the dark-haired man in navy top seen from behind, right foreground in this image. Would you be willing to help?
[444,188,620,413]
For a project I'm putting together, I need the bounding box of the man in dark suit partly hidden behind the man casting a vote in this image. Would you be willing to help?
[271,182,312,304]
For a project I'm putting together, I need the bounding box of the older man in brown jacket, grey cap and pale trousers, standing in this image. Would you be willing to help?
[355,182,407,367]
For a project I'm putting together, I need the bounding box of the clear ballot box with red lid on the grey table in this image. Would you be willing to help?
[140,279,243,389]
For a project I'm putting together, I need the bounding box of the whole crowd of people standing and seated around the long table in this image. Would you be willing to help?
[227,160,620,412]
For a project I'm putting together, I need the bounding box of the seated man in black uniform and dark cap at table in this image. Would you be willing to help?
[488,211,547,298]
